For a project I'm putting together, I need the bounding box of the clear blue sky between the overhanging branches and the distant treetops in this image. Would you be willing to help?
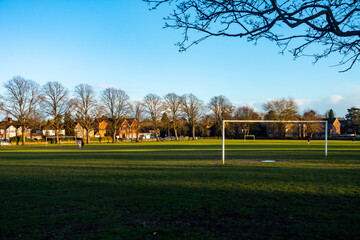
[0,0,360,117]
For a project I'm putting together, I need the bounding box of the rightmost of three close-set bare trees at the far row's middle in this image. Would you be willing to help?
[181,93,204,140]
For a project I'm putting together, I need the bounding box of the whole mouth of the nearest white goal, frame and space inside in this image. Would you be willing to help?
[222,120,328,165]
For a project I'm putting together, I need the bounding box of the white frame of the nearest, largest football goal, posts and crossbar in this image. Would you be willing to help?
[222,120,328,165]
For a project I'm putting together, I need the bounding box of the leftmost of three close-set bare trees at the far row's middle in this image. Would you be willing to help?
[143,93,163,141]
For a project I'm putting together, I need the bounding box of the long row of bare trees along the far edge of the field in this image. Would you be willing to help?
[0,76,360,144]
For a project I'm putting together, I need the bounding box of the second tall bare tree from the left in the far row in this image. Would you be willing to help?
[42,82,69,141]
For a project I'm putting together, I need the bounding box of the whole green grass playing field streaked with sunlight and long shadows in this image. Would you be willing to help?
[0,140,360,239]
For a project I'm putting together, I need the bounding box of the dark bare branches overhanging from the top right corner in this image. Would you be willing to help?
[144,0,360,71]
